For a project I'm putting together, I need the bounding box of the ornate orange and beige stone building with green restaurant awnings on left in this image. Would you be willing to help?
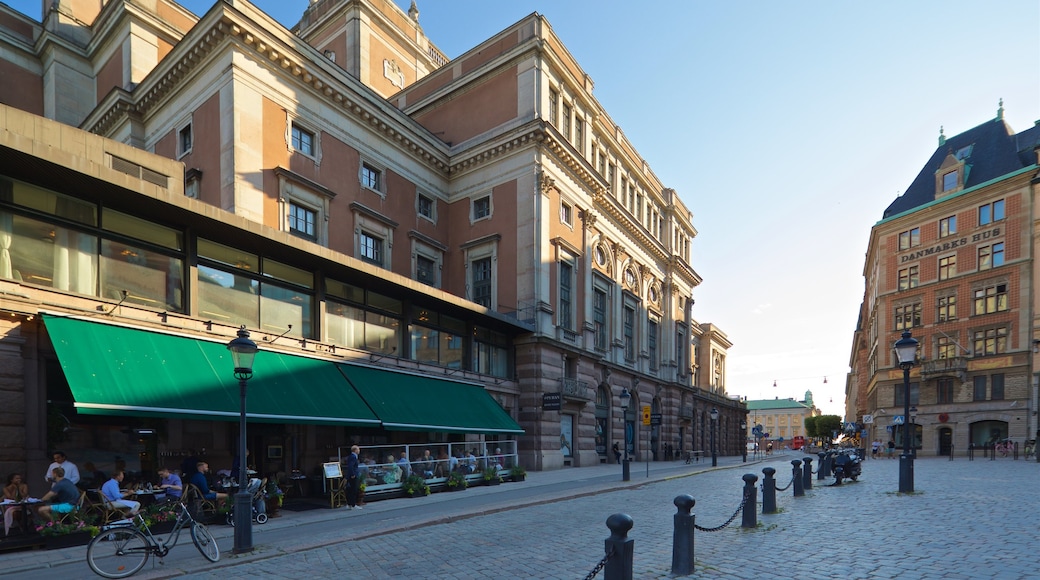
[0,0,744,490]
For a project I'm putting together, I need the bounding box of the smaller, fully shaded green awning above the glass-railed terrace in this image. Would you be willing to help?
[338,364,523,433]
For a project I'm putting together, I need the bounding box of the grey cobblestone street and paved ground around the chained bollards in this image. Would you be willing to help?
[0,454,1040,580]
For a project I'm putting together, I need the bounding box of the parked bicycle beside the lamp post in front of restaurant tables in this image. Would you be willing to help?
[86,501,220,578]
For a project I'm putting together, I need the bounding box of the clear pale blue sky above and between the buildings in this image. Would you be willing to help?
[8,0,1040,415]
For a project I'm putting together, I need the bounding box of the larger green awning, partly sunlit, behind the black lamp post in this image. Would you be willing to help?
[44,315,380,427]
